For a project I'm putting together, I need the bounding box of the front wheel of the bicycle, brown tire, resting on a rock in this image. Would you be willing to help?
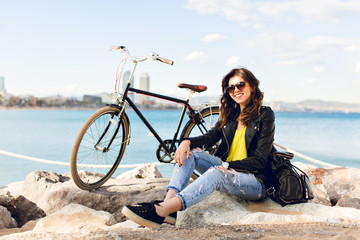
[70,106,130,190]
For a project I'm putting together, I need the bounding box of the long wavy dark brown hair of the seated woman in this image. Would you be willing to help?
[220,68,264,128]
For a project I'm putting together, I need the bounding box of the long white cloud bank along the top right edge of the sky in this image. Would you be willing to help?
[187,0,360,28]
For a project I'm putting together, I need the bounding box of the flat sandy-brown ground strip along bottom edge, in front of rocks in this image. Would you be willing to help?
[0,223,360,240]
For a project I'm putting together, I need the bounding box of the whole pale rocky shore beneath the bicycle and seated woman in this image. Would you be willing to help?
[0,162,360,240]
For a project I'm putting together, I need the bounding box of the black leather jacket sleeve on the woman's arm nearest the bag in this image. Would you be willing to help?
[229,108,275,172]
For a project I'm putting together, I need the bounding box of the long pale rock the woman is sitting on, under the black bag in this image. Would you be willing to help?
[176,192,360,227]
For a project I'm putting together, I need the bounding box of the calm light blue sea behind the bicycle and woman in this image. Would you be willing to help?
[0,110,360,186]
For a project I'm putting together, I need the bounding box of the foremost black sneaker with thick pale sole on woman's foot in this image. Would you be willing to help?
[121,203,165,228]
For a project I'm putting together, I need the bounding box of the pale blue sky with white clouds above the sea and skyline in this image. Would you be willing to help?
[0,0,360,104]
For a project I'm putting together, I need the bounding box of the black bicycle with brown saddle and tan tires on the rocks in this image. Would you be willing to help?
[70,46,219,190]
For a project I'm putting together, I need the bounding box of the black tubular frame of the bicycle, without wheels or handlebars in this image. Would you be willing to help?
[125,87,195,157]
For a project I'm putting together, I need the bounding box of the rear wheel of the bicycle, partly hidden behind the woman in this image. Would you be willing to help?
[181,106,220,179]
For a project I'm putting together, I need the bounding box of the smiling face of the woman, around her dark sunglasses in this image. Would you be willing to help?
[228,76,251,109]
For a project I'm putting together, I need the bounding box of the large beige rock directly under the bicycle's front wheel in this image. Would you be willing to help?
[4,171,169,222]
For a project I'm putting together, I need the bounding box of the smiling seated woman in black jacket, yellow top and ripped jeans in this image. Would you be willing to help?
[122,68,275,228]
